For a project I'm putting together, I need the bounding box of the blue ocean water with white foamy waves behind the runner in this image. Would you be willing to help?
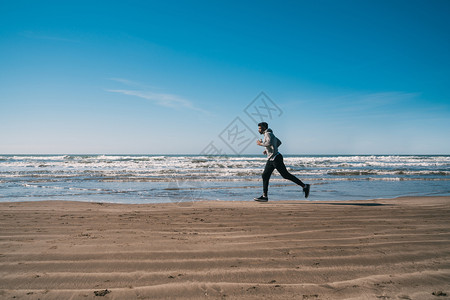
[0,155,450,203]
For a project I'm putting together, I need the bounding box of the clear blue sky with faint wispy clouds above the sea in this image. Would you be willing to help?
[0,0,450,154]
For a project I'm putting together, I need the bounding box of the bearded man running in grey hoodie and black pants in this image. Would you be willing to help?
[255,122,310,202]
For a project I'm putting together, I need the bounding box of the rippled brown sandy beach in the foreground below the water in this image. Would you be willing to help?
[0,197,450,299]
